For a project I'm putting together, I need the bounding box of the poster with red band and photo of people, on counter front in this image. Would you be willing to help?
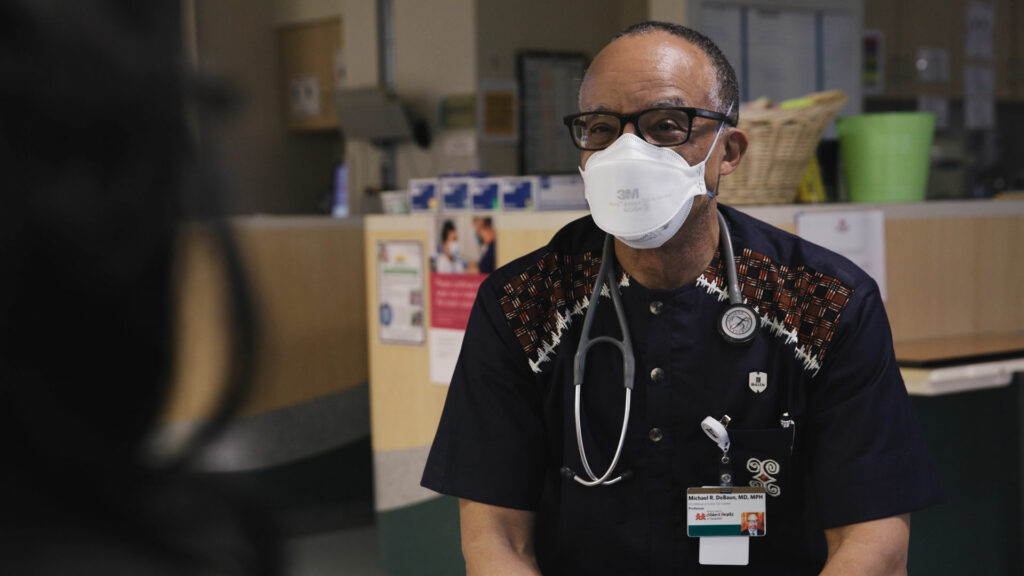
[429,212,497,385]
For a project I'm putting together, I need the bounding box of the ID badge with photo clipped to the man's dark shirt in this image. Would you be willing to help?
[686,486,767,566]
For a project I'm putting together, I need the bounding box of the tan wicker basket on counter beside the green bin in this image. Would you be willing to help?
[719,90,846,204]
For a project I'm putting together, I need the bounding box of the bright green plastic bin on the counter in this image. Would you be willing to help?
[836,112,935,202]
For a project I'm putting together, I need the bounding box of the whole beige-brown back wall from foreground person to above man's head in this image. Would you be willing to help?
[195,0,670,213]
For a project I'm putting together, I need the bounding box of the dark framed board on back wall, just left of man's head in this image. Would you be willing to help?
[516,51,587,174]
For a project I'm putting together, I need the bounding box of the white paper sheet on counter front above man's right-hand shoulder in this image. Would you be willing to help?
[797,210,887,300]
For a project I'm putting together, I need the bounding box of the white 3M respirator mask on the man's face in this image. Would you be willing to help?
[580,124,724,249]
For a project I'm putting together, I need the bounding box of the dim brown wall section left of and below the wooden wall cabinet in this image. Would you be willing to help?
[195,0,340,213]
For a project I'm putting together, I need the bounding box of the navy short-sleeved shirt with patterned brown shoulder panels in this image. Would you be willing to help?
[422,206,941,576]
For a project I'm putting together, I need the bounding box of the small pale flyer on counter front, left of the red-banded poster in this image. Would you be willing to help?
[377,240,426,344]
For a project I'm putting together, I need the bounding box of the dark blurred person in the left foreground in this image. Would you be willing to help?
[0,0,281,575]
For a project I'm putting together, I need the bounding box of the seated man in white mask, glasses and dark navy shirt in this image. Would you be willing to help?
[423,23,941,576]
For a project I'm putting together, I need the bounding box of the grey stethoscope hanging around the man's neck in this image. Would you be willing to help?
[561,206,758,486]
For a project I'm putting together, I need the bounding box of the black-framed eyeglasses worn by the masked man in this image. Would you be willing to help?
[564,108,736,150]
